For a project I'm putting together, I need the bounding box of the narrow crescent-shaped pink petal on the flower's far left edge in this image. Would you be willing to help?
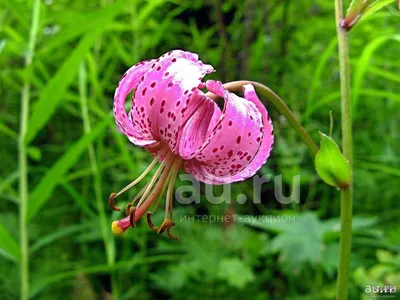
[114,60,155,146]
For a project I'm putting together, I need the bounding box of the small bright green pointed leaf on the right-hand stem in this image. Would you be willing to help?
[315,132,351,189]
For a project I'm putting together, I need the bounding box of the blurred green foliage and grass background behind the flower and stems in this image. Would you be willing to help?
[0,0,400,299]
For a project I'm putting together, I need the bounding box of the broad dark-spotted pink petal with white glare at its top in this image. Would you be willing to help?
[130,50,214,154]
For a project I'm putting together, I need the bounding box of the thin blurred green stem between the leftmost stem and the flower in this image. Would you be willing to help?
[79,62,119,300]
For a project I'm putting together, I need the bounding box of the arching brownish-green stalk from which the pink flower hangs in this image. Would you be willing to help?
[220,80,319,156]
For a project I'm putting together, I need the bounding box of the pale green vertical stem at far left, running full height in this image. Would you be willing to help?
[18,0,40,300]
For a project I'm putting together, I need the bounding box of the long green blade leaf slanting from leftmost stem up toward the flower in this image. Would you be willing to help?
[27,115,112,221]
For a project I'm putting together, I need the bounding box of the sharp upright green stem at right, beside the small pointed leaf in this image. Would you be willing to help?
[335,0,353,300]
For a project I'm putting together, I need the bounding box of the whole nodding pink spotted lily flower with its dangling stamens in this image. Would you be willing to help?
[110,50,274,239]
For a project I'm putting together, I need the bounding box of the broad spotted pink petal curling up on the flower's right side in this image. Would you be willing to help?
[185,80,273,184]
